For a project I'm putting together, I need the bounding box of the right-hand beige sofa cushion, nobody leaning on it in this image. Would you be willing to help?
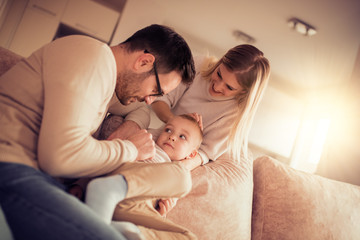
[252,157,360,240]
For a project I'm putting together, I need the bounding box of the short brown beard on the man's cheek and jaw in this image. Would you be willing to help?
[115,70,150,105]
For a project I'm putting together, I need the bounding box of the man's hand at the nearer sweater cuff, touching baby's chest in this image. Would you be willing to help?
[127,129,155,161]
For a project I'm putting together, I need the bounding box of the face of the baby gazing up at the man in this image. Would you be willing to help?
[156,117,200,161]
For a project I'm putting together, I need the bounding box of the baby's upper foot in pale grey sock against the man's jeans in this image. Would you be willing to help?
[85,174,128,224]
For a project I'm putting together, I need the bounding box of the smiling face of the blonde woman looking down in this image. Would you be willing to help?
[209,64,243,97]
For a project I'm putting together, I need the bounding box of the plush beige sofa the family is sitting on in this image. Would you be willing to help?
[0,48,360,240]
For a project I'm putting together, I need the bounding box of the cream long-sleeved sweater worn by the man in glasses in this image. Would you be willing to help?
[0,36,149,177]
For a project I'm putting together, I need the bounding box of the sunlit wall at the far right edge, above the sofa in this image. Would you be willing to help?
[317,46,360,185]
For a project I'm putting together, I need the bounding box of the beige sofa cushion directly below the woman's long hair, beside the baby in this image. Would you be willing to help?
[168,160,253,240]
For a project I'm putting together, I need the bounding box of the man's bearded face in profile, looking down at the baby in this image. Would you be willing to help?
[115,70,181,105]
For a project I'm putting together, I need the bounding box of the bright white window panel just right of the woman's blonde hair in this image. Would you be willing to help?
[249,85,304,163]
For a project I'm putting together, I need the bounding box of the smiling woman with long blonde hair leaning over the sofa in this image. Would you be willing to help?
[152,44,270,169]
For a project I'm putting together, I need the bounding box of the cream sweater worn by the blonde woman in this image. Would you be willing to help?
[156,58,238,164]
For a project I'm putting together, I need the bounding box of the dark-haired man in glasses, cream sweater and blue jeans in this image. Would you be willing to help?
[0,25,194,239]
